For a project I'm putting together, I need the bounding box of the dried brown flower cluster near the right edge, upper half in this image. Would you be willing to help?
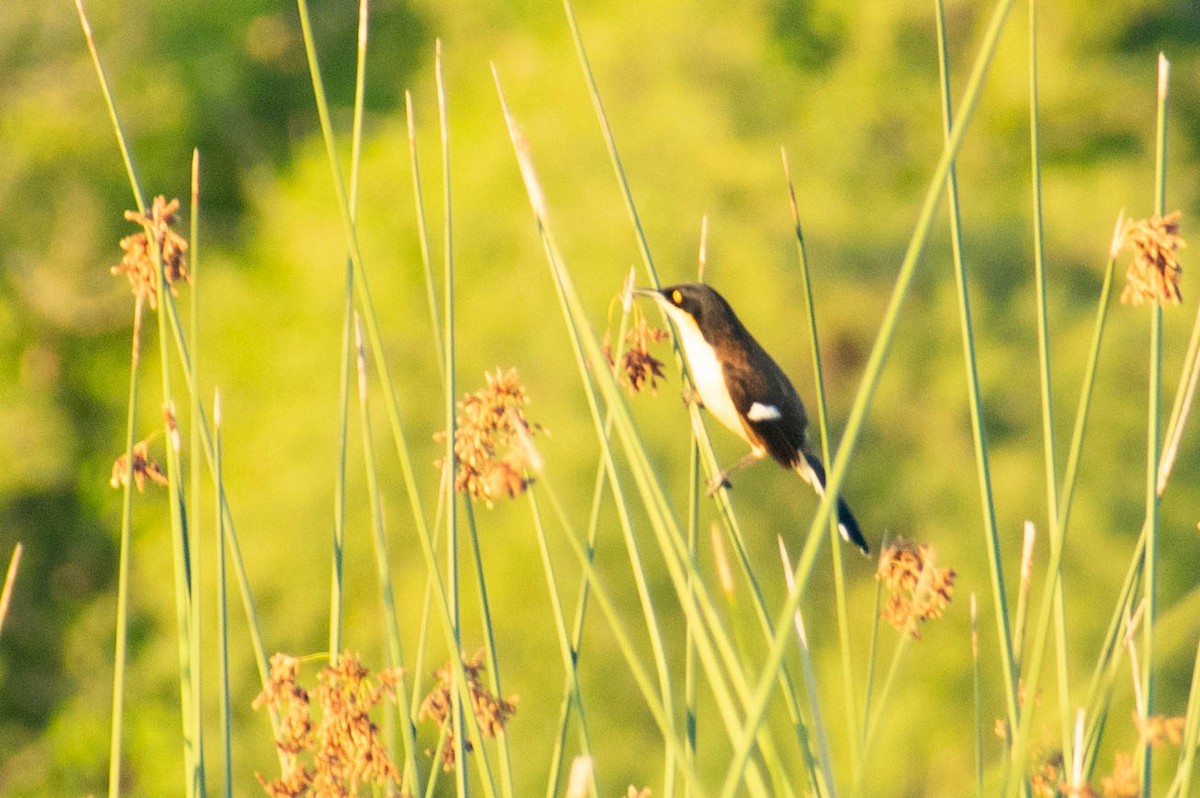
[1120,211,1186,305]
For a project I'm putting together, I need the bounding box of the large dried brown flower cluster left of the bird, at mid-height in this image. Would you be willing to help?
[443,368,542,506]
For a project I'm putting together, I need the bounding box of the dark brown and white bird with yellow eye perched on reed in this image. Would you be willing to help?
[634,283,870,554]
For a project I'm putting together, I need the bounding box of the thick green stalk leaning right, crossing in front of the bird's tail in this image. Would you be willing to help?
[721,0,1013,798]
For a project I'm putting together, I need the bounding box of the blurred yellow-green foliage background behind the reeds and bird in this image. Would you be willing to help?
[0,0,1200,796]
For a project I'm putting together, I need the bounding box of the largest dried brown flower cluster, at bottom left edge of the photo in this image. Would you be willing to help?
[253,652,401,798]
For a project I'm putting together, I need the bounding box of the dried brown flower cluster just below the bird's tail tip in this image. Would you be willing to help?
[875,538,954,640]
